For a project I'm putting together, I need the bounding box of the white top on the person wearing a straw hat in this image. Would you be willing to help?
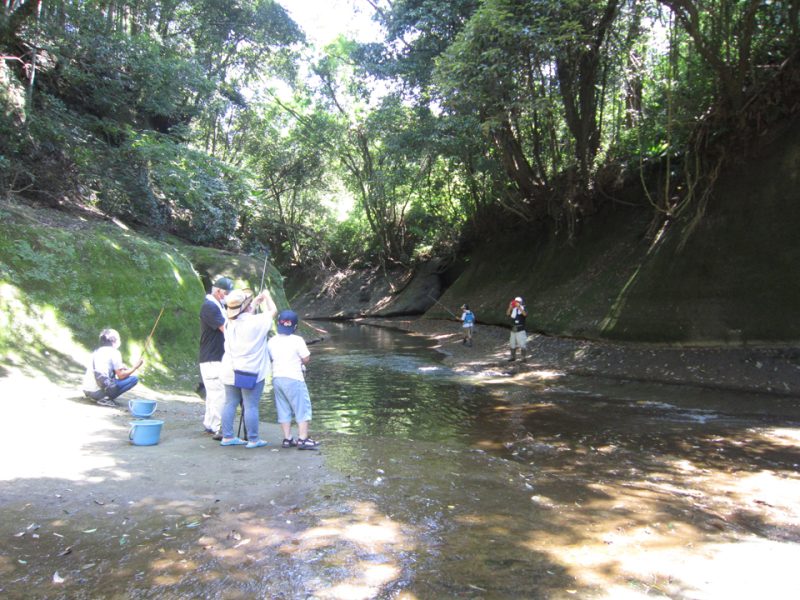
[220,311,274,385]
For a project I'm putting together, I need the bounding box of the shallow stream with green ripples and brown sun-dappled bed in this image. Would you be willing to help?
[269,324,800,598]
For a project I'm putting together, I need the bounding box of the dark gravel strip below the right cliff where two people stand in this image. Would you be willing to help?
[360,318,800,396]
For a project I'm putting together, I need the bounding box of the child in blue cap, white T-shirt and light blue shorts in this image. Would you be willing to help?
[267,310,319,450]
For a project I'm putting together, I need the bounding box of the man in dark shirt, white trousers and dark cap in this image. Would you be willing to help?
[198,277,233,439]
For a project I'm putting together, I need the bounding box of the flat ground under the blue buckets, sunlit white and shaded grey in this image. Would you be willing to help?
[0,373,336,598]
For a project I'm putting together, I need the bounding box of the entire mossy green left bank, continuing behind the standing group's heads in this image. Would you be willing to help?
[0,199,287,389]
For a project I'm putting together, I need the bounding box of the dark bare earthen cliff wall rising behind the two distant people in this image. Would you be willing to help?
[287,122,800,346]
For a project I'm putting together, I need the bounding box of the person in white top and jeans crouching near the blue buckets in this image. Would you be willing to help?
[83,329,143,406]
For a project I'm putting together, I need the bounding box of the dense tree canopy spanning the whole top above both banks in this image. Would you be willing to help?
[0,0,800,265]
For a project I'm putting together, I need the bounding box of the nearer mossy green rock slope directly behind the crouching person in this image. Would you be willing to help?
[0,208,203,384]
